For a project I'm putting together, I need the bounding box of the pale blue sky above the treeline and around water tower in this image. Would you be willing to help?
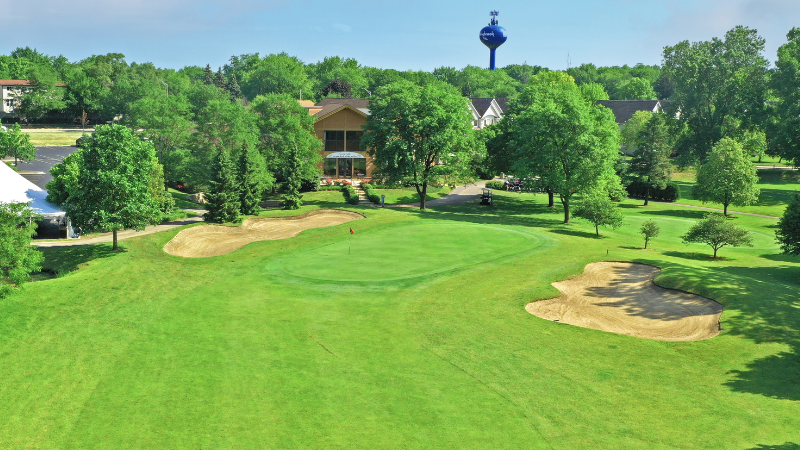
[0,0,800,70]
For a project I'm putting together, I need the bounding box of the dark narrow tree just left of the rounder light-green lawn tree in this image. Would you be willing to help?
[630,114,672,206]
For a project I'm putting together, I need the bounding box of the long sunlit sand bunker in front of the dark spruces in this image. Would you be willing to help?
[164,209,364,258]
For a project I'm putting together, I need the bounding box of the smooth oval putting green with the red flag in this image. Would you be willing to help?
[278,222,549,281]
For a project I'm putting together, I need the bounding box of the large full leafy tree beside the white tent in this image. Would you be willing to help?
[64,125,162,250]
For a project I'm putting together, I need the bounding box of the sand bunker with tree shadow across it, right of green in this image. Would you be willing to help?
[525,262,722,341]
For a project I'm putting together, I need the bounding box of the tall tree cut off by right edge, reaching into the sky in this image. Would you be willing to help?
[767,28,800,166]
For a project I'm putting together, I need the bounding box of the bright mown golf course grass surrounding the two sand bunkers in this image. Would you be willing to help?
[0,199,800,450]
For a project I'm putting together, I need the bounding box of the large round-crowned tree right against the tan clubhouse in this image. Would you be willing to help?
[361,81,472,209]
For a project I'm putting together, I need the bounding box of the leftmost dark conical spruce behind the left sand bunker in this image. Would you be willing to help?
[203,149,240,223]
